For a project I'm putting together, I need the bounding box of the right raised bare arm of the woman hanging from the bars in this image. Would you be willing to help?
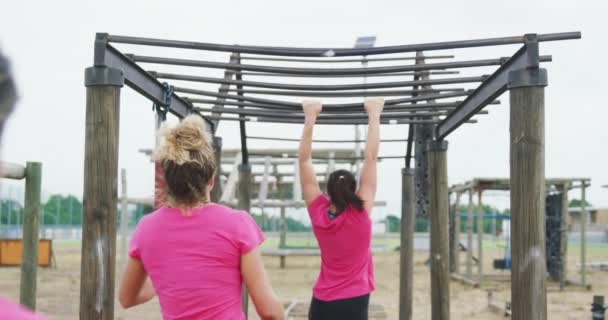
[357,98,384,212]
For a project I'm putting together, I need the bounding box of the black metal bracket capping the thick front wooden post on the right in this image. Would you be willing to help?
[508,34,547,89]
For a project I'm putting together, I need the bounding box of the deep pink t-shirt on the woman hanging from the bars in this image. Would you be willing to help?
[308,195,375,301]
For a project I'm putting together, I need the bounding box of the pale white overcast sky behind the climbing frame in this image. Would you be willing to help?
[0,0,608,220]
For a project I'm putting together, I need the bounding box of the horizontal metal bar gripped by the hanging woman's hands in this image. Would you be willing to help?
[174,87,469,110]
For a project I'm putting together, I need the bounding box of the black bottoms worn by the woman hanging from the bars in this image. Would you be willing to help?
[308,294,369,320]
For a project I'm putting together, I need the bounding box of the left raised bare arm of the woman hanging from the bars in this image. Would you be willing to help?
[298,100,323,206]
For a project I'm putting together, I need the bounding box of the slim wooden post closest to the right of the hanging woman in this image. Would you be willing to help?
[399,169,416,320]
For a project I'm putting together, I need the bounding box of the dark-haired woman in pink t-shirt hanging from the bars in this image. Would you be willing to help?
[299,98,384,320]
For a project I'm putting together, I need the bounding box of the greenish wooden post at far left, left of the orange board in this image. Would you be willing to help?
[19,162,42,310]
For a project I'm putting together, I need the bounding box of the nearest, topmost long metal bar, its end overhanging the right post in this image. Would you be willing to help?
[107,32,581,57]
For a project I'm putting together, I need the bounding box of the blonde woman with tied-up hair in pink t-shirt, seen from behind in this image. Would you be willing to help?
[119,116,283,320]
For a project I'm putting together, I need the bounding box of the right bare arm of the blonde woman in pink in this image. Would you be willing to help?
[241,247,284,320]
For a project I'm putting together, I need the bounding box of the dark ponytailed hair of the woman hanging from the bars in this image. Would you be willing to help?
[327,170,363,214]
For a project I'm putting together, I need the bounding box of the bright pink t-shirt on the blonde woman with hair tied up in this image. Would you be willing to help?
[129,204,264,320]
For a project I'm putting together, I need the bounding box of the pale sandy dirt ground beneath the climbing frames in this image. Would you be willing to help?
[0,242,608,320]
